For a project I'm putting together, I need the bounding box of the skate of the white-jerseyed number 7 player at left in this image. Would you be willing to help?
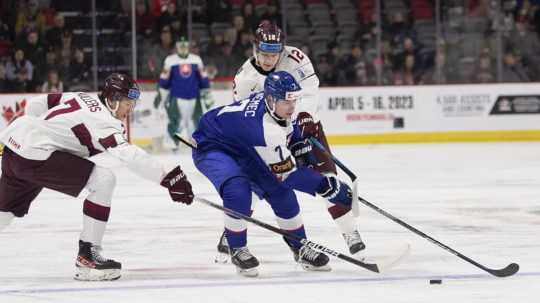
[74,240,122,281]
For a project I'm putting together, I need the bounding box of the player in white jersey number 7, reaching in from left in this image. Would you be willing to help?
[0,74,193,281]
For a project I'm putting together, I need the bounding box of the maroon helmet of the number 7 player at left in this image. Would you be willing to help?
[100,73,141,102]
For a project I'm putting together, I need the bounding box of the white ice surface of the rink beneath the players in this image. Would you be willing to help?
[0,143,540,303]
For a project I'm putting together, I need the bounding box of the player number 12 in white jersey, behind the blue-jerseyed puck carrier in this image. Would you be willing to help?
[216,21,365,261]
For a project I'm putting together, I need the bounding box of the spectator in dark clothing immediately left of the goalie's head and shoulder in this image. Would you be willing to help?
[141,26,174,79]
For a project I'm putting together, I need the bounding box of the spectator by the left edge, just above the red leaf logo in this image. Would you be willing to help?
[6,48,34,92]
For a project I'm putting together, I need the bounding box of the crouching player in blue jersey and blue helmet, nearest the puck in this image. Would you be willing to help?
[193,71,352,276]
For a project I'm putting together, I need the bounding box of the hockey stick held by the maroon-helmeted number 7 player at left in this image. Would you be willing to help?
[194,196,381,273]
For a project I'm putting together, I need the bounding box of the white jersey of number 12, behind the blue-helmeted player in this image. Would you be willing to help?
[233,46,319,121]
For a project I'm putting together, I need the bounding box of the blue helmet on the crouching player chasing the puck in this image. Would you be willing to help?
[264,71,301,101]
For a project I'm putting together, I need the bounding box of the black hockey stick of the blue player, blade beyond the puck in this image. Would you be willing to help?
[309,138,519,277]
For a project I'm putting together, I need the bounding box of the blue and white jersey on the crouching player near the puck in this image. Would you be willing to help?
[193,92,322,195]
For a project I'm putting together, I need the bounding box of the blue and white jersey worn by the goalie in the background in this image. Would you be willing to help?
[159,54,210,99]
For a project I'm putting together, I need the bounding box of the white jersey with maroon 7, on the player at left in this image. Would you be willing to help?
[0,92,169,183]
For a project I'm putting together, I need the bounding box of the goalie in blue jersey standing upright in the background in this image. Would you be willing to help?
[159,38,213,150]
